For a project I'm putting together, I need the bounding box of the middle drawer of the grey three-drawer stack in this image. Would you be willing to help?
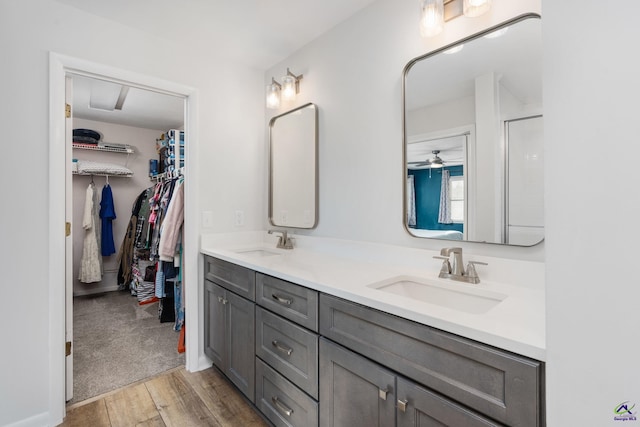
[256,307,318,399]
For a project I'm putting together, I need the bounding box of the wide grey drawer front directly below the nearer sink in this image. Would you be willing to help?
[320,294,543,426]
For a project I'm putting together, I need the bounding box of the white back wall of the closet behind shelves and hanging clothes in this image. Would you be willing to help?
[71,118,168,295]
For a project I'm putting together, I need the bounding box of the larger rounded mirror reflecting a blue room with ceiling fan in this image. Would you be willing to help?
[403,15,544,246]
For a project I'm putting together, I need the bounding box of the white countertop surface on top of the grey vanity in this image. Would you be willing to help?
[200,232,545,361]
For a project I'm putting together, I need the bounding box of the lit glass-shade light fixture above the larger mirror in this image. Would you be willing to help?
[420,0,492,37]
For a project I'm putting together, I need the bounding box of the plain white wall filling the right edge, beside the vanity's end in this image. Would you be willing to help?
[543,0,640,427]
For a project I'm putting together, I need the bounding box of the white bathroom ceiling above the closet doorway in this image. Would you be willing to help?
[56,0,375,70]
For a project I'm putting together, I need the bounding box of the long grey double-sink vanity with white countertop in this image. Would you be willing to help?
[201,232,545,427]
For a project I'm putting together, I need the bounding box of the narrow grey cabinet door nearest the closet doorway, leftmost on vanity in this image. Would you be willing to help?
[204,280,226,372]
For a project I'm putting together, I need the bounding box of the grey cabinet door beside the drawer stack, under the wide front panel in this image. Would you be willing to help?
[320,338,395,427]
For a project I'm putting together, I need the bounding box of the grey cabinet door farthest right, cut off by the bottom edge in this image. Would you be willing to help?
[397,377,503,427]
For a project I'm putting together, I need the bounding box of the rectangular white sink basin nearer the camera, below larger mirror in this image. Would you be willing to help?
[367,276,507,314]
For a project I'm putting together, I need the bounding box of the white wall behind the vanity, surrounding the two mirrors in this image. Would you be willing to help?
[264,0,544,260]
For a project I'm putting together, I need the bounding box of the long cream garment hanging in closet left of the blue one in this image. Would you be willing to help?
[78,182,102,283]
